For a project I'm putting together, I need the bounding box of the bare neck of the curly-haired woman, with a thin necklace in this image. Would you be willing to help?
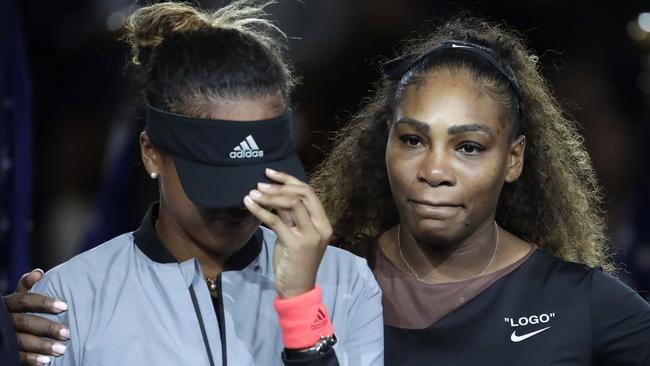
[391,220,499,283]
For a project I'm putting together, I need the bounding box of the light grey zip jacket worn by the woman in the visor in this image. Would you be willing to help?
[32,205,384,366]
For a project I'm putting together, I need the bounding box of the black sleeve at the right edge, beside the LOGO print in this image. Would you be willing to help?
[591,271,650,366]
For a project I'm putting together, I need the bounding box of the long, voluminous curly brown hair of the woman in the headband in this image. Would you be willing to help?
[312,17,613,272]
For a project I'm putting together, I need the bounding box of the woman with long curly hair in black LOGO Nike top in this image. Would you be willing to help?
[312,19,650,365]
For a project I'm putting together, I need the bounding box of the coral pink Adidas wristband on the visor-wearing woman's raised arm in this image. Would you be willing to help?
[275,285,334,349]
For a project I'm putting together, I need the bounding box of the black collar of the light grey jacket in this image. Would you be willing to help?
[133,202,263,271]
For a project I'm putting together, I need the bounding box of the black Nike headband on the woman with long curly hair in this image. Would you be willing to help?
[383,41,523,118]
